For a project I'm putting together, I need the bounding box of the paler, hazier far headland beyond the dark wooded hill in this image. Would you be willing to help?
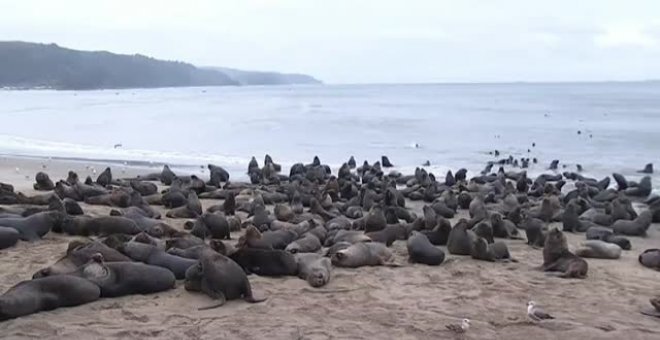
[206,67,322,85]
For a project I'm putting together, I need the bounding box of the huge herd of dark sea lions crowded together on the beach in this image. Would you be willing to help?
[0,156,660,320]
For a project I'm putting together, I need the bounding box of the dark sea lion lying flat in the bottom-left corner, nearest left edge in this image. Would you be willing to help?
[0,275,101,321]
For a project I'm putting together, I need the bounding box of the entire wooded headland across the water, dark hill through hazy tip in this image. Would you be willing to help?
[0,41,319,90]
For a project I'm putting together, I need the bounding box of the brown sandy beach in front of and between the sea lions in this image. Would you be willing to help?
[0,158,660,340]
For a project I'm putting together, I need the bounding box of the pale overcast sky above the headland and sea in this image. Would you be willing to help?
[0,0,660,83]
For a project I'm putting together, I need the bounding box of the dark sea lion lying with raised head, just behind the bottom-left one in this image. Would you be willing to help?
[73,253,175,297]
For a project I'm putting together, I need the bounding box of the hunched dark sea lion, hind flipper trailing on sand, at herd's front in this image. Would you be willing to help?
[184,248,266,309]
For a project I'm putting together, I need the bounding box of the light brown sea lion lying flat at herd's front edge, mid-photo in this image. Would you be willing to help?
[331,242,393,268]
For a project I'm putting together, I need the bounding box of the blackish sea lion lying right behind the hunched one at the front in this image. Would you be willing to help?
[229,247,298,276]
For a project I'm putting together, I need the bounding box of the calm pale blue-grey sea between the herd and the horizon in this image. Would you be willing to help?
[0,82,660,188]
